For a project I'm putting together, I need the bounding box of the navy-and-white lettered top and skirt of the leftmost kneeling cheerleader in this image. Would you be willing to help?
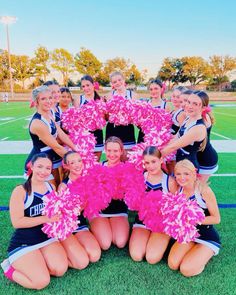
[8,182,53,254]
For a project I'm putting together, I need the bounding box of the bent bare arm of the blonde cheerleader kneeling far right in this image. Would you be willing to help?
[202,187,220,225]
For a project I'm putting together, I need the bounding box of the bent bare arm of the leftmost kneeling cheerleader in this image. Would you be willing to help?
[10,186,59,228]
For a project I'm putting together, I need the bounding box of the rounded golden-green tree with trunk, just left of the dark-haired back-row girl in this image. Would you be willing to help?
[51,48,74,85]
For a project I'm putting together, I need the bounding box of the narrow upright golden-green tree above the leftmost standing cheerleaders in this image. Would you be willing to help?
[32,46,50,82]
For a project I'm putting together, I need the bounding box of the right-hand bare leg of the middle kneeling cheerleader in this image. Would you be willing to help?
[110,216,129,248]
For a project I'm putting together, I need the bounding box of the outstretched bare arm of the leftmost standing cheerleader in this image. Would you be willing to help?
[30,120,67,157]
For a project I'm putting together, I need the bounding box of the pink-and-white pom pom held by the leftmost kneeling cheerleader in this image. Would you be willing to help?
[42,188,81,240]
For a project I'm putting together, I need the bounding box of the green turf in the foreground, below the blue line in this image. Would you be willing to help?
[0,209,236,295]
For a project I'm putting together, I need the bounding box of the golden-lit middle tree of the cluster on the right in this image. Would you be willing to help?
[181,56,210,85]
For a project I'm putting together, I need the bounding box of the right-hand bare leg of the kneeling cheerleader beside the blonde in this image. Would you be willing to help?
[146,233,170,264]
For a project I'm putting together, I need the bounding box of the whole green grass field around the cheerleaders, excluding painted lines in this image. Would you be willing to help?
[0,102,236,295]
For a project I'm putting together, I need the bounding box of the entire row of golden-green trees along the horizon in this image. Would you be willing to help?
[0,46,236,89]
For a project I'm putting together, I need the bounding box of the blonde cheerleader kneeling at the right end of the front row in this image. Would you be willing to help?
[168,160,221,277]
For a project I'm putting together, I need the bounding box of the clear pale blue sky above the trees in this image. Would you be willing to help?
[0,0,236,76]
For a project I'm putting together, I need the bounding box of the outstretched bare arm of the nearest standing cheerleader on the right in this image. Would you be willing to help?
[161,125,206,157]
